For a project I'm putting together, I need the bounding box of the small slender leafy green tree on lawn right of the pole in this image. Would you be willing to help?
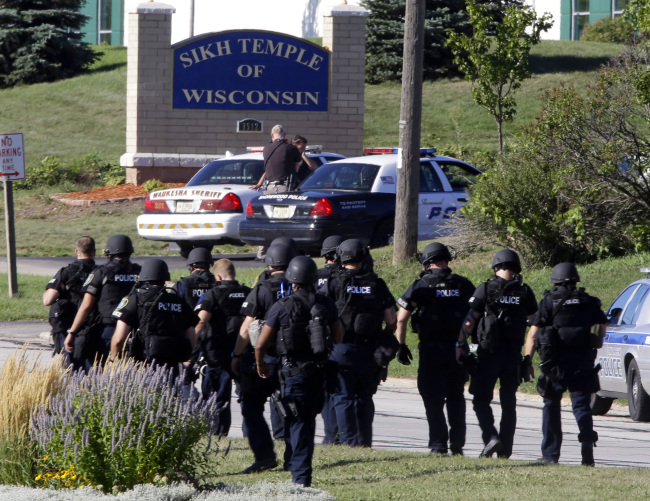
[446,0,552,153]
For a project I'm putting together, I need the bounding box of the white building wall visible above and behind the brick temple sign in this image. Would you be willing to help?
[124,0,360,44]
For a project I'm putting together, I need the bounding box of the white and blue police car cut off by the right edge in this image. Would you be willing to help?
[591,268,650,421]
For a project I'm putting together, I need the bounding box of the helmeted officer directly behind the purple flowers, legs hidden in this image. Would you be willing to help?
[109,259,198,375]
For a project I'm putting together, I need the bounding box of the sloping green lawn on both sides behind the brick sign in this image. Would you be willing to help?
[0,41,619,175]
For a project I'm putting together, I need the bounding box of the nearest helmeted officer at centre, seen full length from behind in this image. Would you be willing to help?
[255,256,343,487]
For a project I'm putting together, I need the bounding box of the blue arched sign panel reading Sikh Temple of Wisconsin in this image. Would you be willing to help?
[172,31,330,111]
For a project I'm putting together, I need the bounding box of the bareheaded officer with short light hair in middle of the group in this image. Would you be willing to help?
[195,259,251,436]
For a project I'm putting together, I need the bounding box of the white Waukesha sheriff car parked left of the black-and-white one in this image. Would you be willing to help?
[137,147,345,257]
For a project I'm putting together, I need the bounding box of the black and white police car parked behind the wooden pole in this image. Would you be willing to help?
[239,148,481,252]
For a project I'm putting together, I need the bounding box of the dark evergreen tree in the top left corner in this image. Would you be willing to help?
[0,0,101,87]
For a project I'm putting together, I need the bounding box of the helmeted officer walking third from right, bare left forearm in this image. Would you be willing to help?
[396,242,475,455]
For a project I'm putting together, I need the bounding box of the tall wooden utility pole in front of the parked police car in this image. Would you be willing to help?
[393,0,426,264]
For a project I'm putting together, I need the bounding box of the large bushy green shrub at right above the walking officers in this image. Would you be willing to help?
[463,40,650,265]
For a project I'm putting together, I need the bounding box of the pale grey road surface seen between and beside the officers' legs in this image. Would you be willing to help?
[0,322,650,468]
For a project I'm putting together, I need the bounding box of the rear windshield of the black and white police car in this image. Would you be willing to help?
[300,162,379,191]
